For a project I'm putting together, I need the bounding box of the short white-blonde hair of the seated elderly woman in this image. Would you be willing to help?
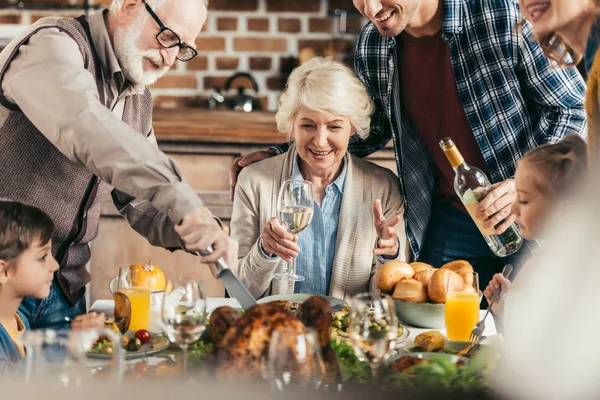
[275,57,374,138]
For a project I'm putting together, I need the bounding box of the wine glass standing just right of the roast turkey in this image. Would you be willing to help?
[348,293,398,382]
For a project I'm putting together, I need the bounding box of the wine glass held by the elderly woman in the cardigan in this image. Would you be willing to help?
[273,180,314,282]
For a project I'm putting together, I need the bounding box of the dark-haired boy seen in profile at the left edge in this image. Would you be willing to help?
[0,199,104,375]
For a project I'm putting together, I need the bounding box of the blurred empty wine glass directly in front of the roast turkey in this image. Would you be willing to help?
[268,327,322,391]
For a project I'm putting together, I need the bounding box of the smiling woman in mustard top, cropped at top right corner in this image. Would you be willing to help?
[519,0,600,155]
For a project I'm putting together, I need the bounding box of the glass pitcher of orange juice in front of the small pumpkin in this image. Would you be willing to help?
[113,265,150,331]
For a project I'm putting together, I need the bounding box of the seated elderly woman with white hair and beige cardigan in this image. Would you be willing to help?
[231,58,408,299]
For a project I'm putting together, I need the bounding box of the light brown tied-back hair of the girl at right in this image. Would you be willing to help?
[521,135,588,197]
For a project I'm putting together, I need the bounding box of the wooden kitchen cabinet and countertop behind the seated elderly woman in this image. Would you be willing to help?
[88,109,396,304]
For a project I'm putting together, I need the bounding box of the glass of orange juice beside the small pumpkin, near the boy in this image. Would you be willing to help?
[115,265,150,331]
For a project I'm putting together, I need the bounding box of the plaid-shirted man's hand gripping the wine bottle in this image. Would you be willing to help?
[477,179,517,234]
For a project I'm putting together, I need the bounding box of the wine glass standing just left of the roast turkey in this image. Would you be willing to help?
[161,277,206,380]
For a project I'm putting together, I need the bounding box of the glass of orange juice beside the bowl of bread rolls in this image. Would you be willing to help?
[445,272,480,342]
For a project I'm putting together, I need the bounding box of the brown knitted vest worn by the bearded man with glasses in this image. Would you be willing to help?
[0,17,152,305]
